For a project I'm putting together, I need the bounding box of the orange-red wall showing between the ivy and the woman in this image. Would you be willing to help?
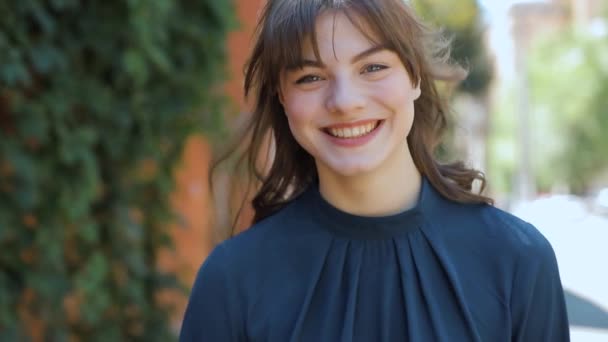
[160,0,263,329]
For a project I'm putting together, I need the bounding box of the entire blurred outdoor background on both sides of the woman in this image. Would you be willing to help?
[0,0,608,342]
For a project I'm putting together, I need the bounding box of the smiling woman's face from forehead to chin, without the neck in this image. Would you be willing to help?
[279,12,420,179]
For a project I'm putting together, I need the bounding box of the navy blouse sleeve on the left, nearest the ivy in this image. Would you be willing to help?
[179,245,245,342]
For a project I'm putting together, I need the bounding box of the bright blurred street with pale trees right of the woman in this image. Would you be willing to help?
[481,0,608,342]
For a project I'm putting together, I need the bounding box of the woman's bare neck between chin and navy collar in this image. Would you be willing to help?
[317,144,422,216]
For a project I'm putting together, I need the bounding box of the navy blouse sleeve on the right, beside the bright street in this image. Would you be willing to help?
[511,230,570,342]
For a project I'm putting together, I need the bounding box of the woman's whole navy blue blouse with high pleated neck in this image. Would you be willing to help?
[180,180,569,342]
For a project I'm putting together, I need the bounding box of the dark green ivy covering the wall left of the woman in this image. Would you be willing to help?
[0,0,234,341]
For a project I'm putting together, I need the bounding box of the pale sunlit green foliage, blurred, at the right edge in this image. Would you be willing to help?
[529,29,608,193]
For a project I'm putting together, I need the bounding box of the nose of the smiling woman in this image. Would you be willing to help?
[326,78,365,114]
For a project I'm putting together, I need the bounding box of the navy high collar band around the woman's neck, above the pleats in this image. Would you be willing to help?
[302,177,440,240]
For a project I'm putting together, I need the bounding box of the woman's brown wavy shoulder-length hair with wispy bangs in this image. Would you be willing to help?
[212,0,492,234]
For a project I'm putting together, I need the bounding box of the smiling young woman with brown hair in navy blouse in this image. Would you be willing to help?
[180,0,569,341]
